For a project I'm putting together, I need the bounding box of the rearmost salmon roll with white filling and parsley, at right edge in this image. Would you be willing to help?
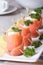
[29,11,42,29]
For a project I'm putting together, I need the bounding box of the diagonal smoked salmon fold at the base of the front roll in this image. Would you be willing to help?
[10,44,23,56]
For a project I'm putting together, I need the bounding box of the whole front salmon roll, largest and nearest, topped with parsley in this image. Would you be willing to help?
[6,27,23,56]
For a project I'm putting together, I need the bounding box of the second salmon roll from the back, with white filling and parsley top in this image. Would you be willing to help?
[24,17,39,37]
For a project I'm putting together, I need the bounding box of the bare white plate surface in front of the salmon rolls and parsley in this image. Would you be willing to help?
[0,41,43,62]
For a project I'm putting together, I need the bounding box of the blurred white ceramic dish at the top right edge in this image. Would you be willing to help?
[16,0,43,8]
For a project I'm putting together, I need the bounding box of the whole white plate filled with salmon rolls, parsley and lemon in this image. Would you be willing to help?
[0,9,43,62]
